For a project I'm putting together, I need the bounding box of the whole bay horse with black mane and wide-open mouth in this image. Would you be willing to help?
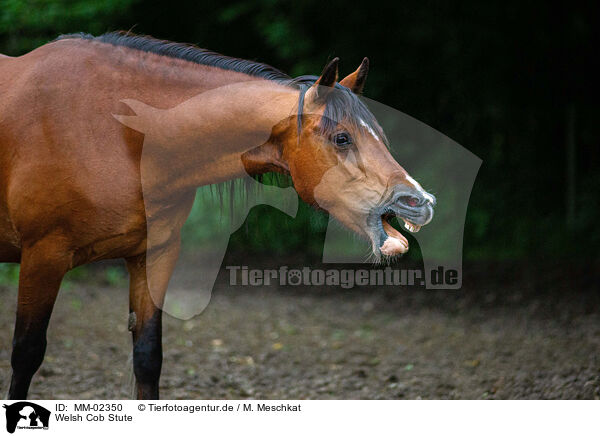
[0,32,435,399]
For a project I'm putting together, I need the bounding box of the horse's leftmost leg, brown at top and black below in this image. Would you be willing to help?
[8,240,70,400]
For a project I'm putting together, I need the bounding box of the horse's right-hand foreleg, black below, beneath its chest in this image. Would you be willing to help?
[126,243,179,400]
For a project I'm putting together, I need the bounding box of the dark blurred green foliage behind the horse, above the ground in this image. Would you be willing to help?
[0,0,600,262]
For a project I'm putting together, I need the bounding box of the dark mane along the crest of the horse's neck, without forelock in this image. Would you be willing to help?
[56,31,290,82]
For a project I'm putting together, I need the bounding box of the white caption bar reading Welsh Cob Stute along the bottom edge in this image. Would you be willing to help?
[0,400,600,436]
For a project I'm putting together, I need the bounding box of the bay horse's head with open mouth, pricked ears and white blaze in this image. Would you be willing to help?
[242,58,436,259]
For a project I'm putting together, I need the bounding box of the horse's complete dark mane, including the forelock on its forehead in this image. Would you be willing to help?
[57,31,387,143]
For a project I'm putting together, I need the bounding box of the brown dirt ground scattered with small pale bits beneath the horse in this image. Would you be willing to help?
[0,260,600,399]
